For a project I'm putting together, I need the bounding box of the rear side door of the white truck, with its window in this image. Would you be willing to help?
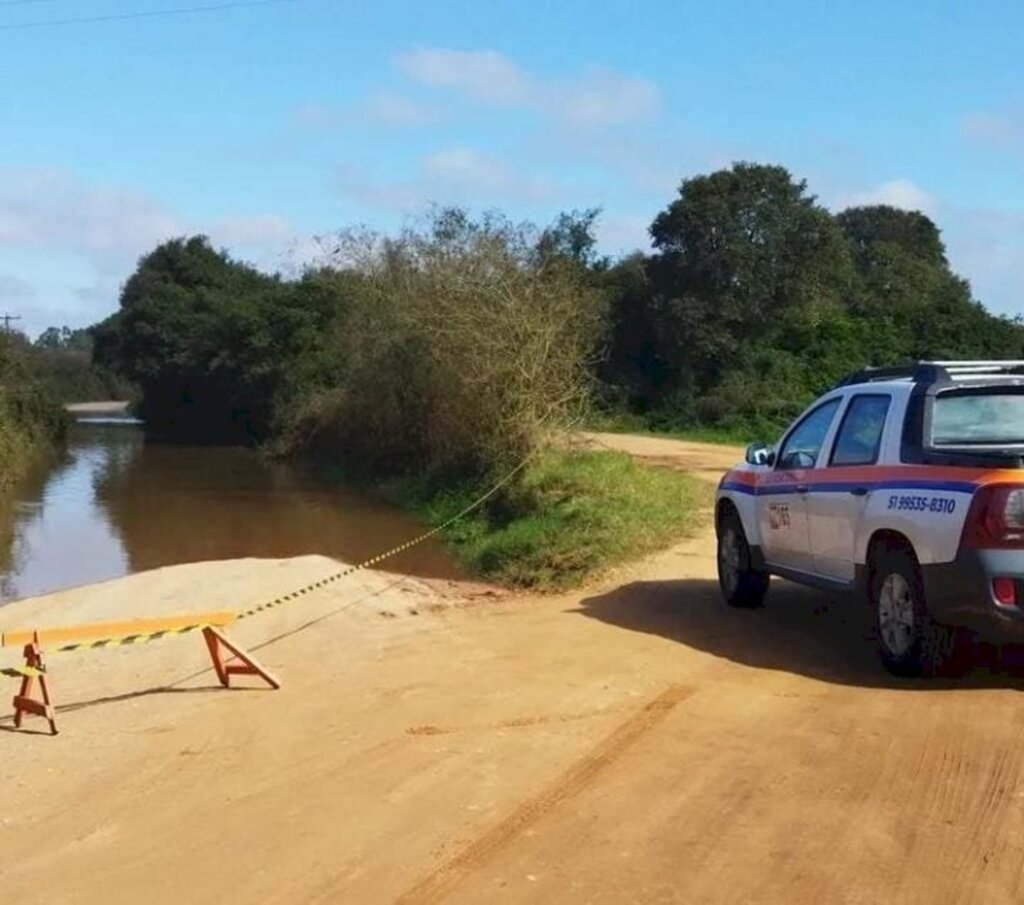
[807,392,892,581]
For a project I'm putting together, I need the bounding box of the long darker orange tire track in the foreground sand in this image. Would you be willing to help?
[396,685,696,905]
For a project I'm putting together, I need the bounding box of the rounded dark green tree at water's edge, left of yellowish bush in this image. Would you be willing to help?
[95,236,329,441]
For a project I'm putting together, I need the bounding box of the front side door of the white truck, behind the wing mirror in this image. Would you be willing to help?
[757,397,842,572]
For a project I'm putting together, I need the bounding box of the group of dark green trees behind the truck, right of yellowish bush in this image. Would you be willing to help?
[599,164,1024,432]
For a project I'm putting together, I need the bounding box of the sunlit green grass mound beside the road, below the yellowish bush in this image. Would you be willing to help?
[397,451,713,591]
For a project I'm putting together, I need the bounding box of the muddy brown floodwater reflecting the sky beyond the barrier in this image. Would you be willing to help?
[0,418,459,604]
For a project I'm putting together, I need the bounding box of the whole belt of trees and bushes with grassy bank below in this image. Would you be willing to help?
[83,164,1024,587]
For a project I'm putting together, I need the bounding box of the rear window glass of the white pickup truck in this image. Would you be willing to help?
[932,388,1024,446]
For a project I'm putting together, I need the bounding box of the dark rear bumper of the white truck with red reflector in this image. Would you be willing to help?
[921,550,1024,640]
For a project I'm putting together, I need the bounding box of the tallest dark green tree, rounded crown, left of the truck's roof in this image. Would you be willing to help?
[634,163,853,427]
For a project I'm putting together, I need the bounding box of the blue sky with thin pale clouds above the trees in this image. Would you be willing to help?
[0,0,1024,334]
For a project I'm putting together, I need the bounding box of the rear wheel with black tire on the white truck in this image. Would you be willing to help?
[869,550,956,676]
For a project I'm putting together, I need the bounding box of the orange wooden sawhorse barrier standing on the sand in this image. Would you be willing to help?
[0,612,281,735]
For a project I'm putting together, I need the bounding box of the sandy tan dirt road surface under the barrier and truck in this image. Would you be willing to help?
[0,438,1024,905]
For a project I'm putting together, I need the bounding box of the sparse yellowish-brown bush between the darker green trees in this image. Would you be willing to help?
[285,210,603,478]
